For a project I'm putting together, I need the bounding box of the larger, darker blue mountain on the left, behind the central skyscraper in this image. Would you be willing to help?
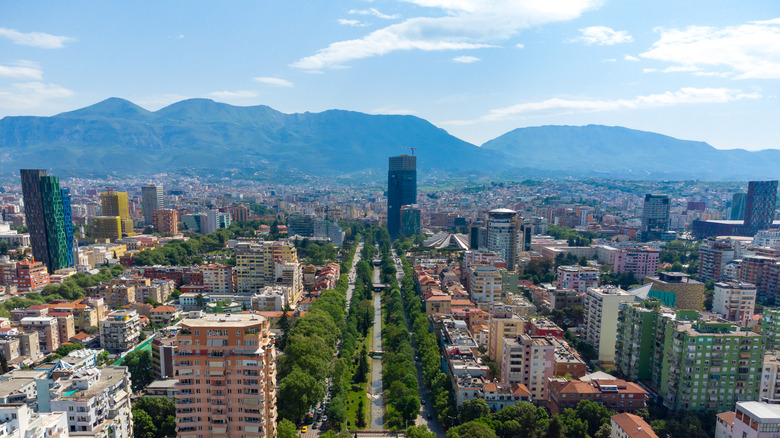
[0,98,498,173]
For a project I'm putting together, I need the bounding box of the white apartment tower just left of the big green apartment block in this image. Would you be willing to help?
[585,286,636,362]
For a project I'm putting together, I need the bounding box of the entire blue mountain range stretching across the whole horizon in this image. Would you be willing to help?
[0,98,780,180]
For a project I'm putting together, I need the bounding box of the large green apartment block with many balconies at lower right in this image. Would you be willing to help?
[615,302,766,412]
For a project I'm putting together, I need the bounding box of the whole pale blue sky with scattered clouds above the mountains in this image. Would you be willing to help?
[0,0,780,150]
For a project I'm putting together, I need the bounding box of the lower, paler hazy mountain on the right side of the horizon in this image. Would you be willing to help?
[482,125,780,180]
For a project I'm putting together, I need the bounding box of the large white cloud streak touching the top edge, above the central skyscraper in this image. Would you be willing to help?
[292,0,602,70]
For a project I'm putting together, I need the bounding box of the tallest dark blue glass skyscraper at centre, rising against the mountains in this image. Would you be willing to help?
[387,155,417,237]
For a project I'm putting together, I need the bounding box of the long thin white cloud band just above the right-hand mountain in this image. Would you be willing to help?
[447,88,761,125]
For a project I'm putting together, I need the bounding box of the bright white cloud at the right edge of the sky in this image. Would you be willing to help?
[639,18,780,79]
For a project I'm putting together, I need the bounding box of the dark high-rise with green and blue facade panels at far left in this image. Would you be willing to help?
[20,169,73,273]
